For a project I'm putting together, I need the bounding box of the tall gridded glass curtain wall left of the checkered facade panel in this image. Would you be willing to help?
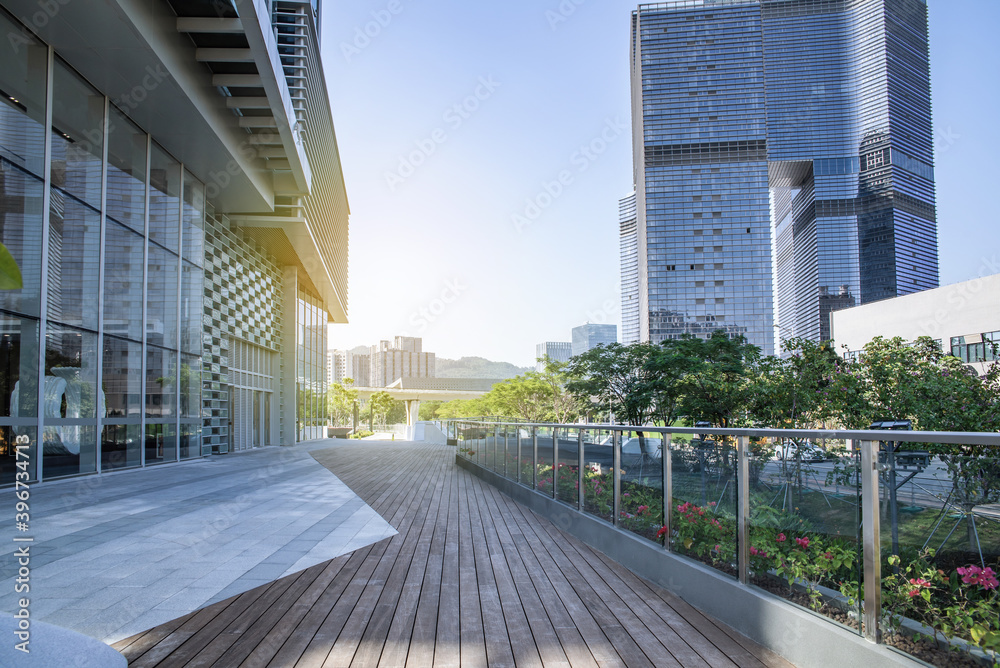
[0,7,205,485]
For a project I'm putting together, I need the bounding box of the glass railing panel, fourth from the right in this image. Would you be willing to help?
[618,431,665,541]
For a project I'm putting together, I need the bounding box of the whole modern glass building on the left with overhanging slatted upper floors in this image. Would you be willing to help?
[0,0,348,484]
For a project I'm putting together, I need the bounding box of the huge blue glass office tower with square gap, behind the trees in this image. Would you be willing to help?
[632,0,938,353]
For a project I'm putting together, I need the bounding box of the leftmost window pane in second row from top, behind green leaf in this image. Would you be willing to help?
[0,163,43,316]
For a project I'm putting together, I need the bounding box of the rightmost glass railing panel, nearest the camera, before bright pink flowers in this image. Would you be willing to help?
[879,442,1000,665]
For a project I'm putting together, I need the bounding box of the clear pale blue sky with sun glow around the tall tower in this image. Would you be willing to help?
[322,0,1000,365]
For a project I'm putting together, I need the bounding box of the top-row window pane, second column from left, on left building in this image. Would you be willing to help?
[51,60,104,209]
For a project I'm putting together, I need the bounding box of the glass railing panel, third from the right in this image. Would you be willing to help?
[671,435,737,577]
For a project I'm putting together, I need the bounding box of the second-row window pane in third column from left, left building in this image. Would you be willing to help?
[104,220,144,342]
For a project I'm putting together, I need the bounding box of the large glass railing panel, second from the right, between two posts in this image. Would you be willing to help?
[749,439,861,633]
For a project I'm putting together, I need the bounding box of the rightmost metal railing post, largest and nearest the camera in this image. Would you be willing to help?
[852,441,882,643]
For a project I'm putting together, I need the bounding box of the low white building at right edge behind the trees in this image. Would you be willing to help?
[830,274,1000,374]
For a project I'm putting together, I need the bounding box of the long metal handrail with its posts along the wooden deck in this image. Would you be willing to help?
[452,419,1000,643]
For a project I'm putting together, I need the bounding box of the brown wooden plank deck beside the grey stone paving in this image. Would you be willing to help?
[115,443,790,668]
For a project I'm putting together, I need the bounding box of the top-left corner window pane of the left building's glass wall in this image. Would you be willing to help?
[0,15,48,176]
